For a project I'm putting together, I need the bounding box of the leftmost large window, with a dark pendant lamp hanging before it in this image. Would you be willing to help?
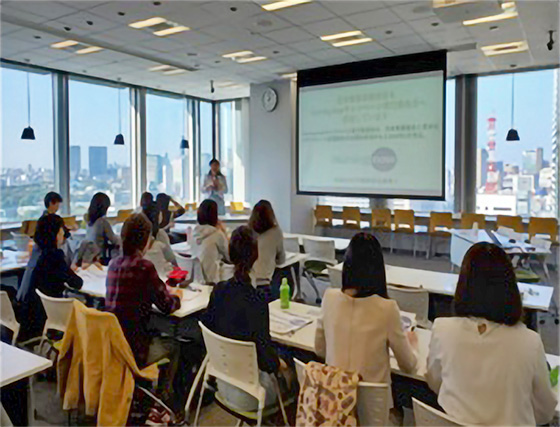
[0,68,55,222]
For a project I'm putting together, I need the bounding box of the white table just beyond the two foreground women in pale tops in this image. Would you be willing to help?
[328,263,554,311]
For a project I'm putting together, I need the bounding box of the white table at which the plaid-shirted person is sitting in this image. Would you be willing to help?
[78,266,212,318]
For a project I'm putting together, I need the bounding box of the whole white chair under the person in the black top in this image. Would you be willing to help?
[193,322,289,427]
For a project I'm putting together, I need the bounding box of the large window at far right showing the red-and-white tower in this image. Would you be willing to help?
[476,70,558,217]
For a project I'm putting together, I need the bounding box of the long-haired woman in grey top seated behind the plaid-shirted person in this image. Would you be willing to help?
[86,193,121,264]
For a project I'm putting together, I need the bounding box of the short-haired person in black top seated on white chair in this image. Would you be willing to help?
[203,227,287,411]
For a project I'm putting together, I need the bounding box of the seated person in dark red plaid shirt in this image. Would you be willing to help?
[105,214,189,412]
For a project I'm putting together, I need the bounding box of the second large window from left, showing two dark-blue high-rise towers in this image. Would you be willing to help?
[69,79,132,215]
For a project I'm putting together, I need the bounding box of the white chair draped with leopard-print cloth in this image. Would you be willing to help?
[294,359,391,426]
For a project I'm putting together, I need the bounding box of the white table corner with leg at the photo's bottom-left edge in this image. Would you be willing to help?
[0,343,52,425]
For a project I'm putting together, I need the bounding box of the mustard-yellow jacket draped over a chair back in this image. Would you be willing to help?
[57,301,158,426]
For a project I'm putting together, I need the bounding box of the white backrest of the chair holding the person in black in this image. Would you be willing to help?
[198,322,264,399]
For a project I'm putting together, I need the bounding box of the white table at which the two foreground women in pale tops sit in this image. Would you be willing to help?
[269,300,560,417]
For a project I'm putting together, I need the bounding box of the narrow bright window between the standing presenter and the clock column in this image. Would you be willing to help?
[218,99,246,202]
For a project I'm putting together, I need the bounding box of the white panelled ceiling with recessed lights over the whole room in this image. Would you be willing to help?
[0,0,560,99]
